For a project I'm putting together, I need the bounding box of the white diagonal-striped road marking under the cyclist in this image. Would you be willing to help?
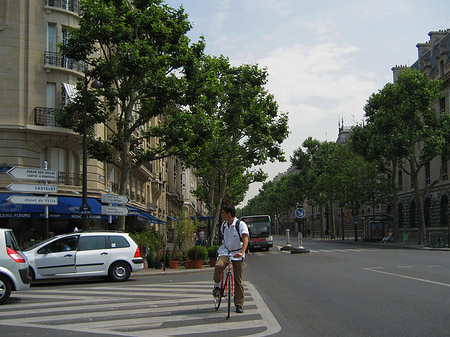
[0,281,281,337]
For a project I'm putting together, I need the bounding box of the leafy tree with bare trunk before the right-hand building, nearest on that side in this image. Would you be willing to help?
[363,69,442,242]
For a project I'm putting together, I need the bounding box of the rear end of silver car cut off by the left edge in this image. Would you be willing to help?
[0,228,31,304]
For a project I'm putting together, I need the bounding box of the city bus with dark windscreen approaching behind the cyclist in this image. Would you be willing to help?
[240,215,273,250]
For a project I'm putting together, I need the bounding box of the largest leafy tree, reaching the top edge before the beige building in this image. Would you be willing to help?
[59,0,207,229]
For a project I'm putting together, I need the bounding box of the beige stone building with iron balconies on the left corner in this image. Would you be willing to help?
[0,0,205,241]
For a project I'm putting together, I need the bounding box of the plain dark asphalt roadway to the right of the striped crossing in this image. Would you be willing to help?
[246,236,450,337]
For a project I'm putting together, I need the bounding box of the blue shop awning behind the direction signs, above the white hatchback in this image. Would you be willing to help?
[0,193,108,220]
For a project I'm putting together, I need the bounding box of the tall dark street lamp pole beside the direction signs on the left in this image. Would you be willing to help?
[80,72,101,229]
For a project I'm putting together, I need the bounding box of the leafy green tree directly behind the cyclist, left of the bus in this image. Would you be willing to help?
[185,56,288,239]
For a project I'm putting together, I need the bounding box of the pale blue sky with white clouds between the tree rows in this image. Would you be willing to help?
[166,0,450,206]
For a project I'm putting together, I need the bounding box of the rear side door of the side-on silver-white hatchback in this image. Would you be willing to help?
[75,235,111,276]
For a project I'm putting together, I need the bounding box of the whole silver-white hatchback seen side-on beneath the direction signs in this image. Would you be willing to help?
[23,232,144,281]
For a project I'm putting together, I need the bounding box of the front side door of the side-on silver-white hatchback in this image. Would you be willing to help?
[34,235,78,276]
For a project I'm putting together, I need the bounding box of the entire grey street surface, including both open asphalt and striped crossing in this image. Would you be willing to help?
[0,239,450,337]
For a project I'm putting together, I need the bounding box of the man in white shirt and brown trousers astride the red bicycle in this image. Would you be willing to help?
[213,204,249,313]
